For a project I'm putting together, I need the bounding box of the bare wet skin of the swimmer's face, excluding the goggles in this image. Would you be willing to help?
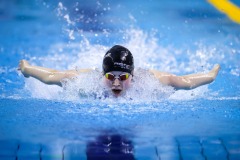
[104,71,132,97]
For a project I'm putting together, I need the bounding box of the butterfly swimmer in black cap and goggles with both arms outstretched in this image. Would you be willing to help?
[18,45,220,97]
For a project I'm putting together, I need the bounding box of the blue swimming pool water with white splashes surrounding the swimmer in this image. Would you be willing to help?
[0,0,240,159]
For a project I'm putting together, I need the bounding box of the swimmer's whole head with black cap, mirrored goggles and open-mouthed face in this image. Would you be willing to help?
[103,45,134,96]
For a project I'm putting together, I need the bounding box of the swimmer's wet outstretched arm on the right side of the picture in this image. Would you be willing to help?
[150,64,220,90]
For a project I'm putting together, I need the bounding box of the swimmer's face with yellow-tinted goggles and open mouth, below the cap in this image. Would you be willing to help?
[104,71,132,96]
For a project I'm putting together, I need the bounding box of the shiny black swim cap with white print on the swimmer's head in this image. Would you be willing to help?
[102,45,134,74]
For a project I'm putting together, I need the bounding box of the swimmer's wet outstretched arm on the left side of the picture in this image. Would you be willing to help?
[18,60,91,86]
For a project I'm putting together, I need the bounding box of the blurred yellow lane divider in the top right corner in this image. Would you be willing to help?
[208,0,240,24]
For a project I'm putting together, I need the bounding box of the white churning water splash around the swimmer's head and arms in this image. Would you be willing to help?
[21,28,218,102]
